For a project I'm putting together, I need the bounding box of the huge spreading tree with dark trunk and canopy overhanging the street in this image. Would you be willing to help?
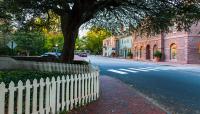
[0,0,200,62]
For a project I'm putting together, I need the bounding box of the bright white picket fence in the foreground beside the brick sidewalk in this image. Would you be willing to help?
[0,71,99,114]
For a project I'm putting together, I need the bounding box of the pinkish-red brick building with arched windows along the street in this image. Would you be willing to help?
[132,25,200,63]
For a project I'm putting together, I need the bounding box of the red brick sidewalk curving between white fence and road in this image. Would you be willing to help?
[69,76,166,114]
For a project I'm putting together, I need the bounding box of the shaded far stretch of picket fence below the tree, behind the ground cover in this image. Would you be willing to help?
[18,61,93,74]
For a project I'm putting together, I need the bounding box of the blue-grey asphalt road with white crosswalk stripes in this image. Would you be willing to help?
[87,56,200,114]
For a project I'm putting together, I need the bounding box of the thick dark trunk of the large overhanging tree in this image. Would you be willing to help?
[61,15,79,63]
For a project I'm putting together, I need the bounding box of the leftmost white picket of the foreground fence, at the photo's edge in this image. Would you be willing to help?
[0,82,7,114]
